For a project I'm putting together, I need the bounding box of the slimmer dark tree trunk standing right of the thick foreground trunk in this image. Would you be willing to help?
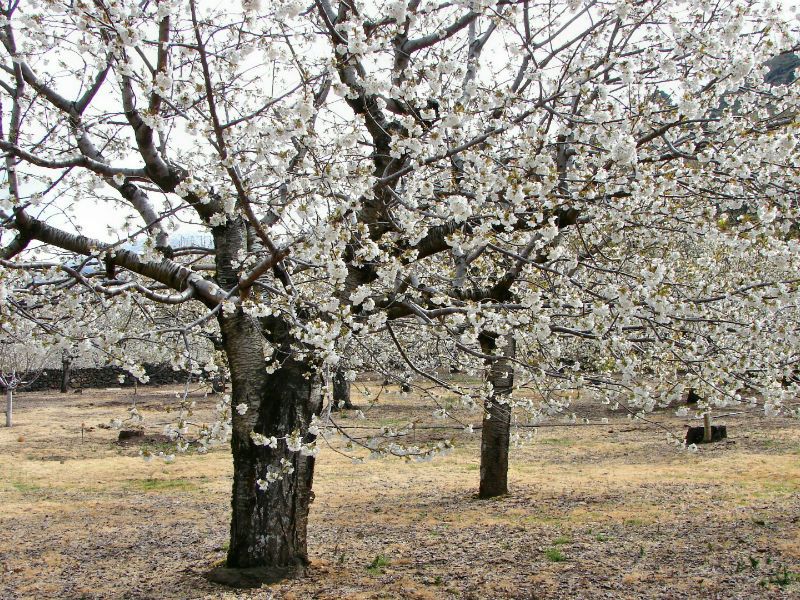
[478,333,515,498]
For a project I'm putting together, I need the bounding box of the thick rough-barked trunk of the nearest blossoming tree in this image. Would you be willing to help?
[209,314,322,587]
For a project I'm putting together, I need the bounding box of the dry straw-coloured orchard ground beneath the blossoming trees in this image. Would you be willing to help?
[0,382,800,599]
